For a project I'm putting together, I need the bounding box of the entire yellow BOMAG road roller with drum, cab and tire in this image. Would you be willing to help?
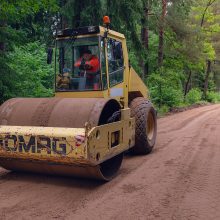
[0,18,157,181]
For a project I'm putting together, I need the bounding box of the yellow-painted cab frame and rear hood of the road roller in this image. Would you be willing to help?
[55,27,149,108]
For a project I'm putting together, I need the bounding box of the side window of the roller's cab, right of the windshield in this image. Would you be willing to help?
[107,39,124,87]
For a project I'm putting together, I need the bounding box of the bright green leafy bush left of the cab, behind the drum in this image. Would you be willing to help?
[8,42,54,97]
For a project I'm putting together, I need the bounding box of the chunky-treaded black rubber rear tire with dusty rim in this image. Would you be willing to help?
[130,97,157,154]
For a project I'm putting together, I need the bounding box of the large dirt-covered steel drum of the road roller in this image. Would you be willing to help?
[0,98,123,180]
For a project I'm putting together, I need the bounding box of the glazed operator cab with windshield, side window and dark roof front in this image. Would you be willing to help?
[55,26,124,92]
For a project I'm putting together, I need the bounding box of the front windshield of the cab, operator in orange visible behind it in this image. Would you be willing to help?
[56,37,101,91]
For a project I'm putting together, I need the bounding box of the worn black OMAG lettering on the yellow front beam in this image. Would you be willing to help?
[0,135,67,155]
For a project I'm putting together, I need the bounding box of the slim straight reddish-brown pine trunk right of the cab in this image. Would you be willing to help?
[158,0,167,67]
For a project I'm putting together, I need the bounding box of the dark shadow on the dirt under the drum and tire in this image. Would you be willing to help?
[0,153,155,190]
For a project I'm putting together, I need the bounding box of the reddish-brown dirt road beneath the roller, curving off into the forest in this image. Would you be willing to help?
[0,105,220,220]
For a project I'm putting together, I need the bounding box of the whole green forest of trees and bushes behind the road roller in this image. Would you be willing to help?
[0,0,220,112]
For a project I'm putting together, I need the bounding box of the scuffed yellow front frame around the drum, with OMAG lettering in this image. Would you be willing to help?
[0,109,135,166]
